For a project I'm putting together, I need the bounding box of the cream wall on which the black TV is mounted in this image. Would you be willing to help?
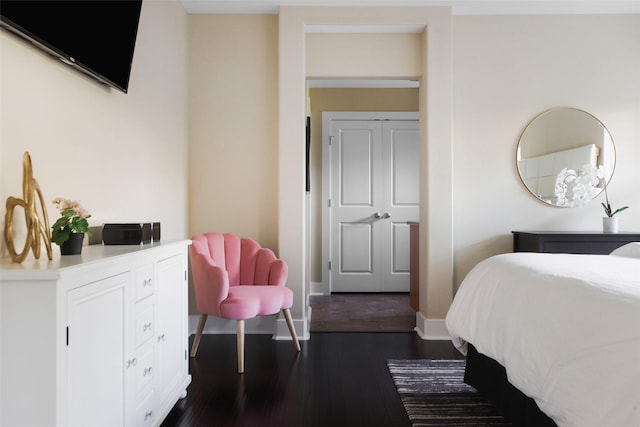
[0,0,188,259]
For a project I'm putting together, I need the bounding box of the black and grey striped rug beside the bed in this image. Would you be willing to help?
[387,359,511,427]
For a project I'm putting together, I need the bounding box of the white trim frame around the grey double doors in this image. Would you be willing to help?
[315,111,420,295]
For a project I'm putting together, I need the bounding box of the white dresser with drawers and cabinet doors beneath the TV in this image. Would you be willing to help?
[0,240,191,427]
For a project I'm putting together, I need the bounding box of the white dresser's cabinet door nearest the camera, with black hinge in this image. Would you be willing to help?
[64,274,130,426]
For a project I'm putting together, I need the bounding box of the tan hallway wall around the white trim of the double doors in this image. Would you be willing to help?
[309,88,419,282]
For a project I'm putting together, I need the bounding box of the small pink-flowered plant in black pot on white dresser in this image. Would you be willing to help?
[51,198,91,255]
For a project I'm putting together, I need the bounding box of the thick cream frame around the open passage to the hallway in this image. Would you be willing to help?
[276,6,454,339]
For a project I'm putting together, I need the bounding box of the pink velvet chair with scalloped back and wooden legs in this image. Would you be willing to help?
[189,233,300,373]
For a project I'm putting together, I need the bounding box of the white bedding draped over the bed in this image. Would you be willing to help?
[446,252,640,427]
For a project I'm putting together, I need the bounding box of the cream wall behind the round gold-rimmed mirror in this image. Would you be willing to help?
[453,15,640,284]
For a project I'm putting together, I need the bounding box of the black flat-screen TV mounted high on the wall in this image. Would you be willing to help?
[0,0,142,93]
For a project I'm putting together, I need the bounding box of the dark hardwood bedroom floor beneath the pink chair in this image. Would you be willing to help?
[162,332,462,427]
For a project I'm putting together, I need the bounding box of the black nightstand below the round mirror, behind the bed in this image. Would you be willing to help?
[512,231,640,255]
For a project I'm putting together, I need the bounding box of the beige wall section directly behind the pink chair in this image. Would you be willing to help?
[189,15,278,251]
